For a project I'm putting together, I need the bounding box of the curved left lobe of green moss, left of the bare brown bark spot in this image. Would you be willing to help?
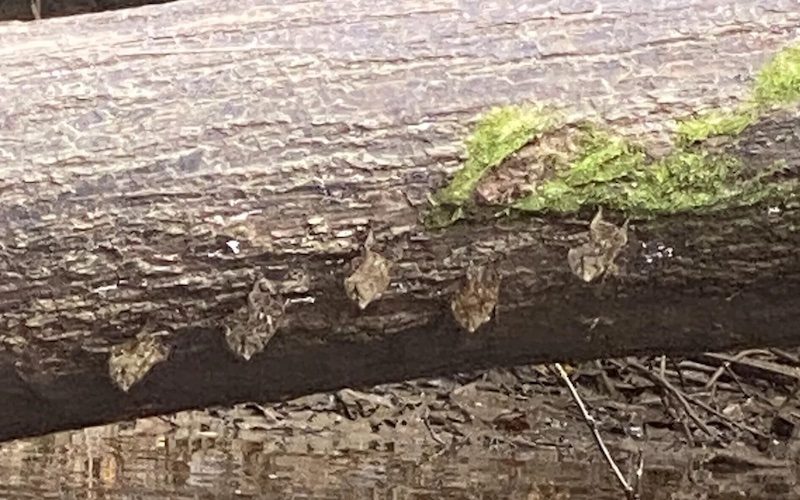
[436,106,557,205]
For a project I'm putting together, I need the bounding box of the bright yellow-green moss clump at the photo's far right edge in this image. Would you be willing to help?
[753,45,800,106]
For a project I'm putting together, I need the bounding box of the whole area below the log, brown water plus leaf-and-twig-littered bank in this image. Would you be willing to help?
[0,349,800,499]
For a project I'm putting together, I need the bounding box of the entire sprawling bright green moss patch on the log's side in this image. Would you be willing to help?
[432,46,800,225]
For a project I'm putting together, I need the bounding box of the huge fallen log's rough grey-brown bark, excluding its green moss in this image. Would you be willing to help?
[0,0,800,438]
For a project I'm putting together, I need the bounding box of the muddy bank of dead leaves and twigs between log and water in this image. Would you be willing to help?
[20,349,800,498]
